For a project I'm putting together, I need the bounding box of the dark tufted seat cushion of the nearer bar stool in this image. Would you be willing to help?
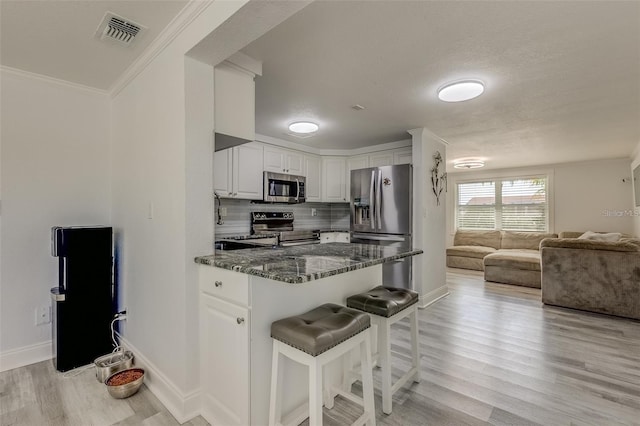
[271,303,371,356]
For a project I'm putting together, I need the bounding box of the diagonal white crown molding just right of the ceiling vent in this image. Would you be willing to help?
[109,0,213,97]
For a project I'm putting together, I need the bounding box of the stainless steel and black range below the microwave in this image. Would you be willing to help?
[251,212,320,247]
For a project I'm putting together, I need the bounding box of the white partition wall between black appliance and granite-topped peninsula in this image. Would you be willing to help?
[112,1,251,421]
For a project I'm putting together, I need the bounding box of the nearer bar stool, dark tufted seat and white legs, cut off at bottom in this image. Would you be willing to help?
[269,303,375,426]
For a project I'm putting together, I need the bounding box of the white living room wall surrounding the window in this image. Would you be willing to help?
[447,159,633,244]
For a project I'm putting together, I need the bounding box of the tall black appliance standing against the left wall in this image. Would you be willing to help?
[51,226,115,371]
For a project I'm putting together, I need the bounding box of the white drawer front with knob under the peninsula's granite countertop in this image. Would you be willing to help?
[200,266,249,306]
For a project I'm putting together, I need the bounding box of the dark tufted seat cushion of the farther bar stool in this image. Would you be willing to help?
[347,286,418,318]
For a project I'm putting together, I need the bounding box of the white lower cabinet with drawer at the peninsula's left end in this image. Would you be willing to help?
[200,266,251,425]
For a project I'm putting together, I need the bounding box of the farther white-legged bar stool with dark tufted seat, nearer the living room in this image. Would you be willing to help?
[347,286,420,414]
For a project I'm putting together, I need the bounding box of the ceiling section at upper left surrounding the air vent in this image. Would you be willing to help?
[0,0,187,90]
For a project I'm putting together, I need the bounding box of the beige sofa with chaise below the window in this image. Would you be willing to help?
[447,231,557,288]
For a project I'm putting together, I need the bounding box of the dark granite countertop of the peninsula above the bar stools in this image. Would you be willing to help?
[195,243,423,284]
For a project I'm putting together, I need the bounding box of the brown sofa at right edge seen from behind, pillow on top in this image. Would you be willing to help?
[540,233,640,320]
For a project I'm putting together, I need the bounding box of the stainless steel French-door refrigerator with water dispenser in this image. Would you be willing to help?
[351,164,413,288]
